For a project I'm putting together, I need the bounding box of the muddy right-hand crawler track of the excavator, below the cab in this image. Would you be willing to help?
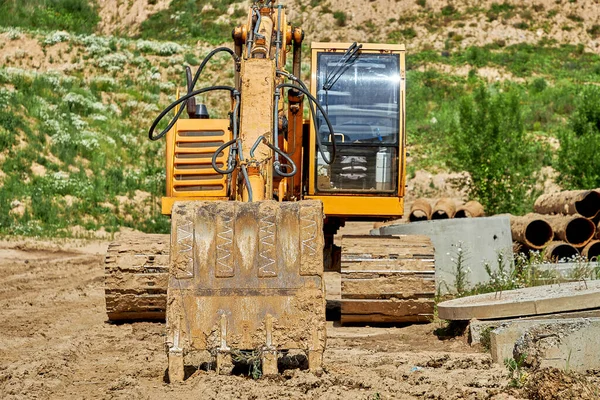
[340,235,435,324]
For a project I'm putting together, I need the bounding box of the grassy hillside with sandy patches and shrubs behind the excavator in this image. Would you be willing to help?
[0,0,600,236]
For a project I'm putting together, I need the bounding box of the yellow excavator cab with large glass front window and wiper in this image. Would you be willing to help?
[307,43,405,219]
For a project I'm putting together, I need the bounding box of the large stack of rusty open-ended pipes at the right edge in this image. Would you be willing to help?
[511,190,600,261]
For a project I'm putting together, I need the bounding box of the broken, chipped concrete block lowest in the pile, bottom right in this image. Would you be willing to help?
[490,318,600,372]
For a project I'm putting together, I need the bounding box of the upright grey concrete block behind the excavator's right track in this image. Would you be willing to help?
[371,216,513,294]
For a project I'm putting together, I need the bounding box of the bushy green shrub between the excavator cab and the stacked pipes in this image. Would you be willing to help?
[448,83,544,214]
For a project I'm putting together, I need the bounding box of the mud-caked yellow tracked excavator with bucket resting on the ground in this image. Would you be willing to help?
[105,1,435,381]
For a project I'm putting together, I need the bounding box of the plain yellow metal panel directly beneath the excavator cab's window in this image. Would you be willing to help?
[304,195,404,218]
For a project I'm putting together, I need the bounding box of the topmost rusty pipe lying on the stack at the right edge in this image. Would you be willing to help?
[533,190,600,218]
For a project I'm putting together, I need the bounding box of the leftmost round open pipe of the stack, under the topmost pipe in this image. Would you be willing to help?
[510,214,554,250]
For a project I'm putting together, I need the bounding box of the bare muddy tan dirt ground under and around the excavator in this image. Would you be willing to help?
[0,236,592,399]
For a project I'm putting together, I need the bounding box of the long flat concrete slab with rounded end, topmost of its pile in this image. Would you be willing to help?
[437,281,600,320]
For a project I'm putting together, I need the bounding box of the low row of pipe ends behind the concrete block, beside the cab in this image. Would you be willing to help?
[408,197,485,222]
